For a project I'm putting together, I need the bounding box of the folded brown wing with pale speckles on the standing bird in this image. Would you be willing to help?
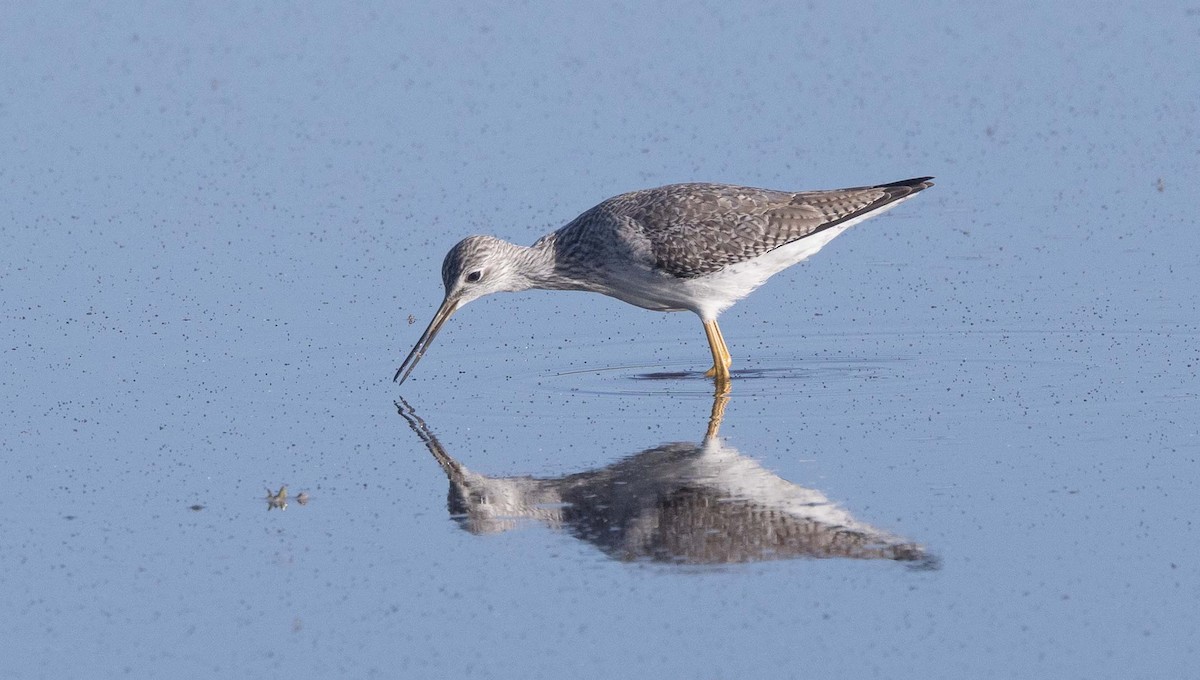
[595,177,932,278]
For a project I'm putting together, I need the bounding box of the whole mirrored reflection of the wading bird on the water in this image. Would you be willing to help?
[397,396,937,568]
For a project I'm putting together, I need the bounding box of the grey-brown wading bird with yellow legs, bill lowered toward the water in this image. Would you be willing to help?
[392,177,934,387]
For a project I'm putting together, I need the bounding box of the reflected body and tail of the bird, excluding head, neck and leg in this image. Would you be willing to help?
[554,438,926,564]
